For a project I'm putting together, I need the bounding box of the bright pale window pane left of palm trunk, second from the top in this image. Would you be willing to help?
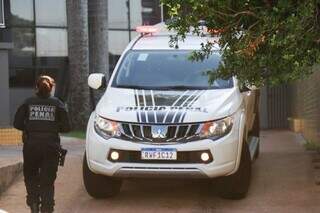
[36,28,68,57]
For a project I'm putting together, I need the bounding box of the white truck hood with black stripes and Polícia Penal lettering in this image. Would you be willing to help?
[96,87,242,124]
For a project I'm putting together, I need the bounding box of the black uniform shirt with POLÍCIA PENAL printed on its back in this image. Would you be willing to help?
[13,97,70,141]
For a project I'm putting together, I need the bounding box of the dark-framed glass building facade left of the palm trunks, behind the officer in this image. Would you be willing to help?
[0,0,68,127]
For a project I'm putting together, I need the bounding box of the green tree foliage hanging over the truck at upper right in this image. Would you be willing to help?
[162,0,320,86]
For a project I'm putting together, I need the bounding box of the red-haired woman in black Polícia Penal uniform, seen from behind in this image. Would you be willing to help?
[14,75,70,213]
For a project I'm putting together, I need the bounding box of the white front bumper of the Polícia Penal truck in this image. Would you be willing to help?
[86,113,242,178]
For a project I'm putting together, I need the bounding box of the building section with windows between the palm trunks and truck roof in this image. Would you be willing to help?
[108,0,162,72]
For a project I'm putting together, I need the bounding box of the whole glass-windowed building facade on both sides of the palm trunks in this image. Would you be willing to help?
[0,0,161,126]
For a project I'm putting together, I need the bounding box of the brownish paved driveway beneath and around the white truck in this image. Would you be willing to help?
[0,131,320,213]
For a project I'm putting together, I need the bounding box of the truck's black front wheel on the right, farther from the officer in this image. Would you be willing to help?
[216,141,251,199]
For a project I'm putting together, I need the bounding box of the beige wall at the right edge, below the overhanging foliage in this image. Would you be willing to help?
[288,66,320,145]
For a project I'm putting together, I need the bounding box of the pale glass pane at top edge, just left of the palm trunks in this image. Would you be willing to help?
[35,0,67,26]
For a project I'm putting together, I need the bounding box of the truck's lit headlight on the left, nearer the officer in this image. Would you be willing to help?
[94,115,121,139]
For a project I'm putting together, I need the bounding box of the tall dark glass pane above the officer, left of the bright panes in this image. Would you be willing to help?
[9,28,35,87]
